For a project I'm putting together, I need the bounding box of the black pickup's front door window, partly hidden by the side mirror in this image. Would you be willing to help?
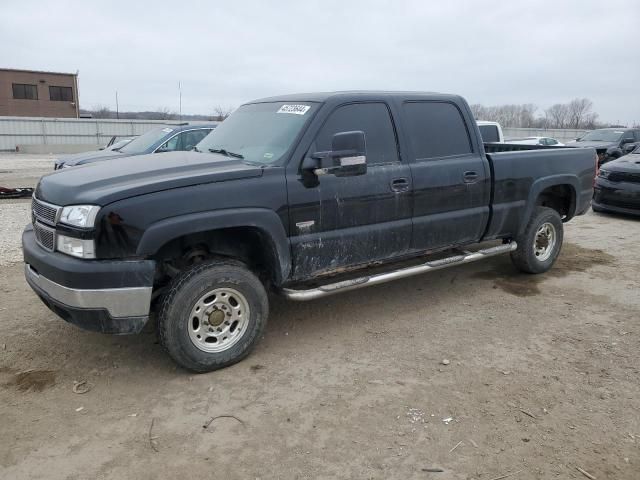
[311,103,399,165]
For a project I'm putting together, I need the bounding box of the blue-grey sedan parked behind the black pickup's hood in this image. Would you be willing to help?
[54,123,216,170]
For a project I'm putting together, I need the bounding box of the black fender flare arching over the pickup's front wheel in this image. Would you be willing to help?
[136,208,291,283]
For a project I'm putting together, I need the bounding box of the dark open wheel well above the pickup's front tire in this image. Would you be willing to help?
[153,227,282,284]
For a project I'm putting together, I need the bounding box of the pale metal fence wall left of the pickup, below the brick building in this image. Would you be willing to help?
[0,117,215,151]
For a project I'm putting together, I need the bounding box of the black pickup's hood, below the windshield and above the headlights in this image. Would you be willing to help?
[36,152,262,206]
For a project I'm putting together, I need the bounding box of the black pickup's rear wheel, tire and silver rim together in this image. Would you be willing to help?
[511,207,564,273]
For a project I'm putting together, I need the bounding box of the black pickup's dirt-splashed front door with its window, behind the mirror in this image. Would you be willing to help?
[287,102,411,279]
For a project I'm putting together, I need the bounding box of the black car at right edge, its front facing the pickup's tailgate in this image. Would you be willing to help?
[591,147,640,215]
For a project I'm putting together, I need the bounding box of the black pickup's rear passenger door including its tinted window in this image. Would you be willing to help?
[401,101,491,250]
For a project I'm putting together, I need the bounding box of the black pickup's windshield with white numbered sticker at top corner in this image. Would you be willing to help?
[197,102,317,165]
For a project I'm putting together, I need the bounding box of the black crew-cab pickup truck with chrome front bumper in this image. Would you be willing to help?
[22,92,596,372]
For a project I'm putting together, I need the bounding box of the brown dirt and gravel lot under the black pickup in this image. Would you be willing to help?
[0,159,640,480]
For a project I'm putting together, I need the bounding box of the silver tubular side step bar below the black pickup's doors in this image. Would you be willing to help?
[282,242,518,302]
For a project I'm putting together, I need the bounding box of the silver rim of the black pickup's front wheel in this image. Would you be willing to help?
[188,287,251,353]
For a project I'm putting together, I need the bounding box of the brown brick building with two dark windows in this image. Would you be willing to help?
[0,68,79,118]
